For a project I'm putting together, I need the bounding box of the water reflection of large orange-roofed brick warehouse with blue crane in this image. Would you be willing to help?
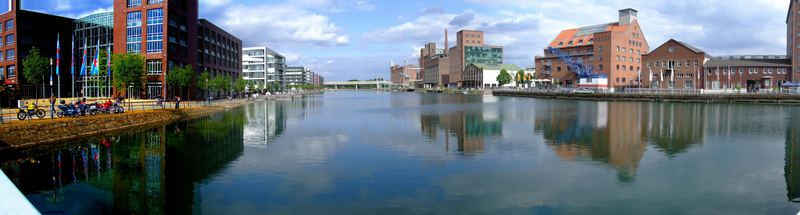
[534,101,647,183]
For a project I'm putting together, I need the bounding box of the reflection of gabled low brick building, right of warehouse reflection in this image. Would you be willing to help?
[645,103,705,157]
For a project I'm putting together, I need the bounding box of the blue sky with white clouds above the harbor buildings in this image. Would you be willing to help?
[14,0,789,81]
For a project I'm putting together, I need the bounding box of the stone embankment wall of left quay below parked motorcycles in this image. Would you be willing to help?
[0,91,319,150]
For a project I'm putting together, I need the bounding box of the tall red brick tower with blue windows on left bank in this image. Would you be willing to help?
[113,0,198,98]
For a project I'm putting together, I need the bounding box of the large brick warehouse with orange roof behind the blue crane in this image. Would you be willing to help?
[535,8,650,88]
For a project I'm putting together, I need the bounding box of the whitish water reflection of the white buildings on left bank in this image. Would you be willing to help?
[244,95,322,145]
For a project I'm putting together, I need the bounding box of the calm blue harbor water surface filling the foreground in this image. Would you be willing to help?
[0,92,800,214]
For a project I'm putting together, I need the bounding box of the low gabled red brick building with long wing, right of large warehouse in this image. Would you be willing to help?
[642,39,792,92]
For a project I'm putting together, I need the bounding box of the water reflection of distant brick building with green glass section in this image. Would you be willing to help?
[420,95,503,153]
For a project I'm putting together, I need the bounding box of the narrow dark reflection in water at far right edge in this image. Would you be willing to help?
[783,111,800,202]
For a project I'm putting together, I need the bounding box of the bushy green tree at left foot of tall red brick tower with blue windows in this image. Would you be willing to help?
[111,54,147,97]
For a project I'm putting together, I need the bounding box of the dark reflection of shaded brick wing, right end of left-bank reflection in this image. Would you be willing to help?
[165,109,245,214]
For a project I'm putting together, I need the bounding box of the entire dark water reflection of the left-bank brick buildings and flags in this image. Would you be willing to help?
[1,107,244,214]
